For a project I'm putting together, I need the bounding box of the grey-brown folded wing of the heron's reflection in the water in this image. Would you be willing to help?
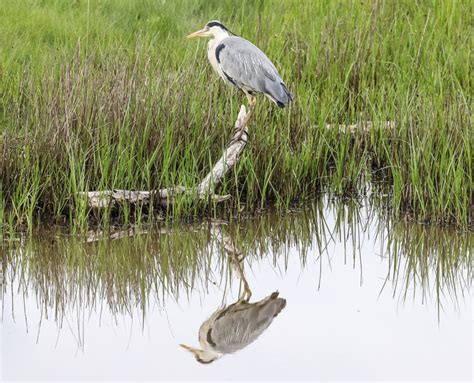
[207,293,286,354]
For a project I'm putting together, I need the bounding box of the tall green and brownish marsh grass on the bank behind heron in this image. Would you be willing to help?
[0,0,474,230]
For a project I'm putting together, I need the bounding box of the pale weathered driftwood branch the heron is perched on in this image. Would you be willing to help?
[80,105,252,209]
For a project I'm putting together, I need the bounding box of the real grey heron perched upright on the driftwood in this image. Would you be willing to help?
[188,20,293,124]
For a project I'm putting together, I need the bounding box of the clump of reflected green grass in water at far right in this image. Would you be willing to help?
[380,222,474,314]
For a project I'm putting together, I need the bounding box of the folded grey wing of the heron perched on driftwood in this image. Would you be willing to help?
[216,36,292,104]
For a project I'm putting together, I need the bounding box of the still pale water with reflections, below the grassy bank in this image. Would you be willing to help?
[1,201,474,381]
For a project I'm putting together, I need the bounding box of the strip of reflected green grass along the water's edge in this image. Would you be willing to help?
[2,201,473,332]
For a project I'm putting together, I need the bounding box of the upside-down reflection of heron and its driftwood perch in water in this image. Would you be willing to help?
[180,225,286,363]
